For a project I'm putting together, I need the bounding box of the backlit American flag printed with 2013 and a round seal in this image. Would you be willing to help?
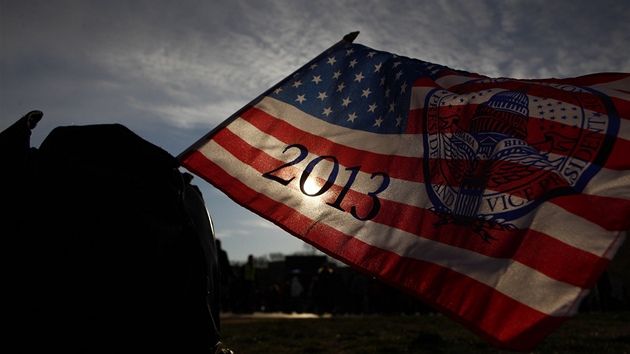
[180,36,630,350]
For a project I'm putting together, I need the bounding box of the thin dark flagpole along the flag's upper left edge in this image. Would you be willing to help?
[177,31,359,166]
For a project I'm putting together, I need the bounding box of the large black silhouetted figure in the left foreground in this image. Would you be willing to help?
[0,111,233,353]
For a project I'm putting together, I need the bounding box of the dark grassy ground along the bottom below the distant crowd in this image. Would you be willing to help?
[221,312,630,354]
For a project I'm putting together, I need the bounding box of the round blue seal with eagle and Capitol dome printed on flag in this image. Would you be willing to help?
[423,79,618,242]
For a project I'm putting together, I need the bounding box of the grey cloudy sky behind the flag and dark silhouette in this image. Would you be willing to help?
[0,0,630,261]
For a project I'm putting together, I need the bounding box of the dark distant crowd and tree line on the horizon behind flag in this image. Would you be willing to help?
[219,250,630,315]
